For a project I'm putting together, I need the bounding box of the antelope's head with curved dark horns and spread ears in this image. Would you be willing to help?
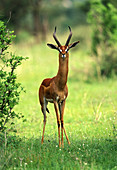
[47,26,80,59]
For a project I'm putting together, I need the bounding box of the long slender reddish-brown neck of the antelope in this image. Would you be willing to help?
[56,53,69,90]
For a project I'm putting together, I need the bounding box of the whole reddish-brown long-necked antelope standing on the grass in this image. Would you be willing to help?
[39,27,79,147]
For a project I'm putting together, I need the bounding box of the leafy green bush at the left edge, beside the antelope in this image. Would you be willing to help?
[0,21,26,131]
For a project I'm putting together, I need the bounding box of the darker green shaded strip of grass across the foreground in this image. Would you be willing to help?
[0,135,117,170]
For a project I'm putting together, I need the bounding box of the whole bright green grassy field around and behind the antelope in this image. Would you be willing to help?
[0,32,117,170]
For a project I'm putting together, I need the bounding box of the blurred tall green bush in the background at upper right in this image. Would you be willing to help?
[88,0,117,77]
